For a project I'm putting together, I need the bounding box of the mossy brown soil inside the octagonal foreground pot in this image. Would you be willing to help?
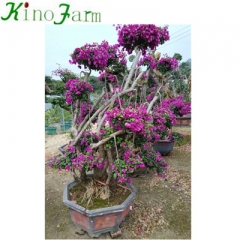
[70,184,131,210]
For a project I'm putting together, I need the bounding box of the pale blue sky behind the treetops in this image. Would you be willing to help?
[45,24,191,79]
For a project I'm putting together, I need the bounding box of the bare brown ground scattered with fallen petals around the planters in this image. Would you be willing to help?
[45,127,191,239]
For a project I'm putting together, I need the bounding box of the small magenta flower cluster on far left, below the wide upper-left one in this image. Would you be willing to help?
[65,79,93,104]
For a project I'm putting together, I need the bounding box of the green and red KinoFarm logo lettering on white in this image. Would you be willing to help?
[1,2,101,25]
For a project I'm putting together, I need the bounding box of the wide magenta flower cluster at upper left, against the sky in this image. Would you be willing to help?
[69,41,126,71]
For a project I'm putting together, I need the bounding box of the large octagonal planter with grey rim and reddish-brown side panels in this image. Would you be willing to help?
[63,181,136,237]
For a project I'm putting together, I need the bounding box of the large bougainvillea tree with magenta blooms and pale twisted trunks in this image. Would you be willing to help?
[48,24,190,201]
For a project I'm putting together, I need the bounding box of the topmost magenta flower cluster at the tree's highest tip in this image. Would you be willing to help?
[116,24,170,55]
